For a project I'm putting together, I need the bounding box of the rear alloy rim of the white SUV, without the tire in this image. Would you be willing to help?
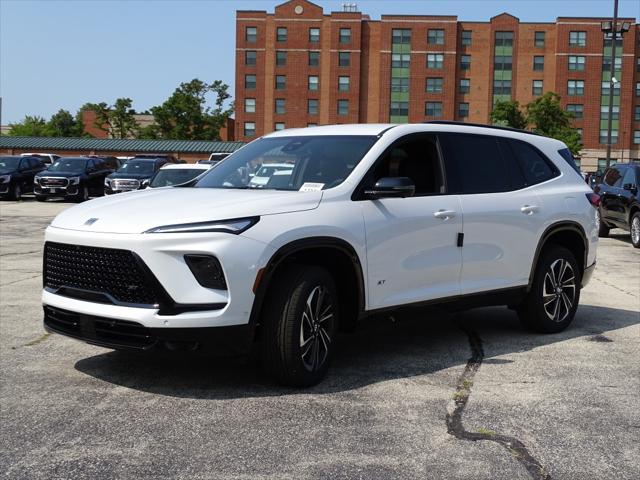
[542,258,576,323]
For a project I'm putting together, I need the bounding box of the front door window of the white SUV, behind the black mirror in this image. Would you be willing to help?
[372,135,444,196]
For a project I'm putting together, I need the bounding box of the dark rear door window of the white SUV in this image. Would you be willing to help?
[440,133,513,194]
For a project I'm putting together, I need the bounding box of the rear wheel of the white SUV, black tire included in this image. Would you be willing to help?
[517,245,582,333]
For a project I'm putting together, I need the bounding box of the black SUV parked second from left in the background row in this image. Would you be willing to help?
[34,157,115,202]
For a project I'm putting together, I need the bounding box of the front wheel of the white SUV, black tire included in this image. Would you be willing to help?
[261,265,339,387]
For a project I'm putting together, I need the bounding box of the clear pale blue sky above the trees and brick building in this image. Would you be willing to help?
[0,0,640,125]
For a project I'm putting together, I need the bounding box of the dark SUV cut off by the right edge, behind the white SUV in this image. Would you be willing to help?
[594,163,640,248]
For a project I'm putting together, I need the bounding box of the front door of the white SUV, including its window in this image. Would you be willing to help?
[360,134,462,309]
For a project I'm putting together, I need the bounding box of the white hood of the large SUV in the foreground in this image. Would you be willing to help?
[51,187,322,233]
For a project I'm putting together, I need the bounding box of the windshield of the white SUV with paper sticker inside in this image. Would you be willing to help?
[195,135,378,190]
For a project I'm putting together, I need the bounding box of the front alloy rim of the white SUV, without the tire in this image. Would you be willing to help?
[300,285,335,372]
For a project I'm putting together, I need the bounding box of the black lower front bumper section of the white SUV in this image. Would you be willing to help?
[44,306,253,355]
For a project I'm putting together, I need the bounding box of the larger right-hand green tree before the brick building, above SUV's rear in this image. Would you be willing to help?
[527,92,582,155]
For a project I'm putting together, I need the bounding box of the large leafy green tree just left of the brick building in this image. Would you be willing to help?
[151,78,233,140]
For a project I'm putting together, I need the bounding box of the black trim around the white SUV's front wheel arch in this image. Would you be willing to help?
[249,237,365,331]
